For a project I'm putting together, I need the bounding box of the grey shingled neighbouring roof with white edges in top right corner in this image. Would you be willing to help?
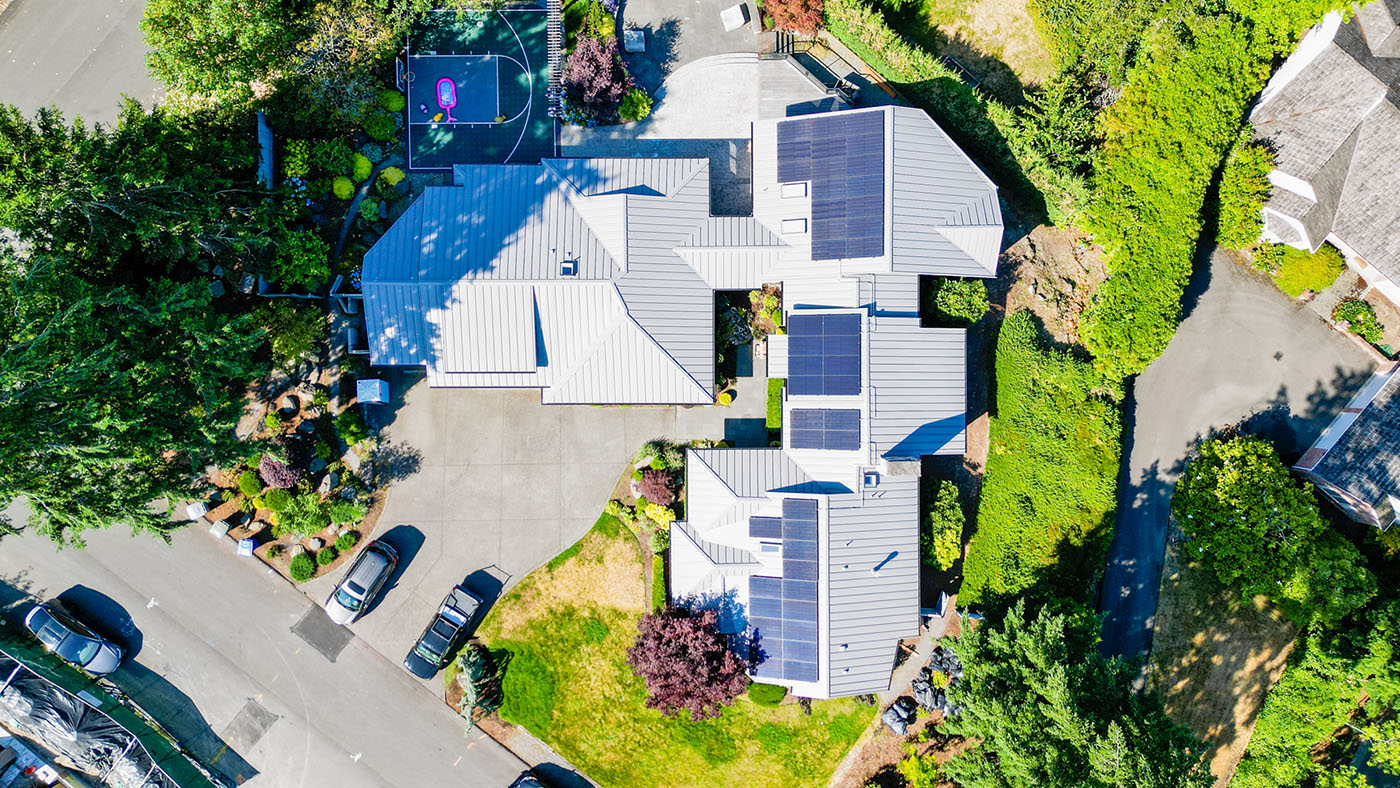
[1250,0,1400,277]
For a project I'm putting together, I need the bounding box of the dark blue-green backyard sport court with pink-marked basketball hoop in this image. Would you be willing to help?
[400,8,557,171]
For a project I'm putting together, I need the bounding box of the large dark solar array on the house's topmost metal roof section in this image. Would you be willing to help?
[778,112,885,260]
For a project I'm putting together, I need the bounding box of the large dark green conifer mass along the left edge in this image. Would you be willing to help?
[0,102,267,544]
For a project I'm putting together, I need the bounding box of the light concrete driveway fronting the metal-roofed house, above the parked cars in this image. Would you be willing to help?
[312,365,767,677]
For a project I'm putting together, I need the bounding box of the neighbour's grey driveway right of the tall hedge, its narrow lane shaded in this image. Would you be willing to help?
[1100,252,1375,658]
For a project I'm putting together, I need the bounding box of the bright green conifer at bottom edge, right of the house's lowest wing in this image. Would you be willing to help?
[944,600,1214,788]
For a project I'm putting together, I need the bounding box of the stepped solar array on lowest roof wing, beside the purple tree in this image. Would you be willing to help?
[749,498,819,682]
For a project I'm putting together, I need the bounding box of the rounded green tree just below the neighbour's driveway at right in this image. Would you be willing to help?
[1172,435,1376,623]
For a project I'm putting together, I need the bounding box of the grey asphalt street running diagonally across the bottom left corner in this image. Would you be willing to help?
[0,517,525,788]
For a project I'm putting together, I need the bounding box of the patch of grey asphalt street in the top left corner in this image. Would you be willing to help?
[0,0,162,123]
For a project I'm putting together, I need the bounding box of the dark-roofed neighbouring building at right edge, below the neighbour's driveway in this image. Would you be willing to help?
[1294,365,1400,530]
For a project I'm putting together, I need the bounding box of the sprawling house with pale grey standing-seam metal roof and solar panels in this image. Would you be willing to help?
[363,106,1002,697]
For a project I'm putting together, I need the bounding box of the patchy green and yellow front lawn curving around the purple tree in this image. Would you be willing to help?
[479,516,875,788]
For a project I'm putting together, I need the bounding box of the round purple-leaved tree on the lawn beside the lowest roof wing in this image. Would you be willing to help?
[627,607,749,719]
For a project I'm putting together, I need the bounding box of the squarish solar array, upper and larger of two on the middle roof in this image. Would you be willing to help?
[788,314,861,395]
